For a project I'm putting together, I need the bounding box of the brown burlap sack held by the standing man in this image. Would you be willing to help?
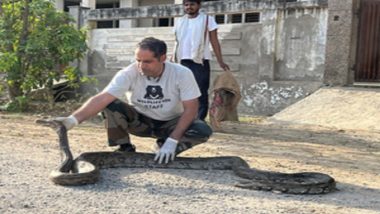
[209,71,241,130]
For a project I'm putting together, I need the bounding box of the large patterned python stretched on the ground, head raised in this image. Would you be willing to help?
[36,119,336,194]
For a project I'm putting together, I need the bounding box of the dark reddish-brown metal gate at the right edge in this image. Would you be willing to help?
[355,0,380,82]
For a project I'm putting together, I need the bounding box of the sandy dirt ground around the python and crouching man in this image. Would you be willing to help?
[0,112,380,214]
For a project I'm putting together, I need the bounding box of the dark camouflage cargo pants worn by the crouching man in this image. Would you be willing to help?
[103,100,212,154]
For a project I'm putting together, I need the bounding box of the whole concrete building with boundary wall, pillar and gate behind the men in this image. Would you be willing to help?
[56,0,380,115]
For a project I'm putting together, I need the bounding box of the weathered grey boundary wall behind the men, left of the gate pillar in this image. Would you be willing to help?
[84,2,328,115]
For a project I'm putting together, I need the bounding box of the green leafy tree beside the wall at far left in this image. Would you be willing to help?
[0,0,87,109]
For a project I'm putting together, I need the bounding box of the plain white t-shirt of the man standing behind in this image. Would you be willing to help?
[174,15,218,59]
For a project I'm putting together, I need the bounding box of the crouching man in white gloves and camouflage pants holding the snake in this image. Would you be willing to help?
[56,37,212,163]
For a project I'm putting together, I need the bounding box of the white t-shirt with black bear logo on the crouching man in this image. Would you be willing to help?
[103,62,201,121]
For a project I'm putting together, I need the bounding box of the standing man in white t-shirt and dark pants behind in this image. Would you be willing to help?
[173,0,229,120]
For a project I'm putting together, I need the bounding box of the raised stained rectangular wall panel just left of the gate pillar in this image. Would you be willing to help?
[274,8,328,81]
